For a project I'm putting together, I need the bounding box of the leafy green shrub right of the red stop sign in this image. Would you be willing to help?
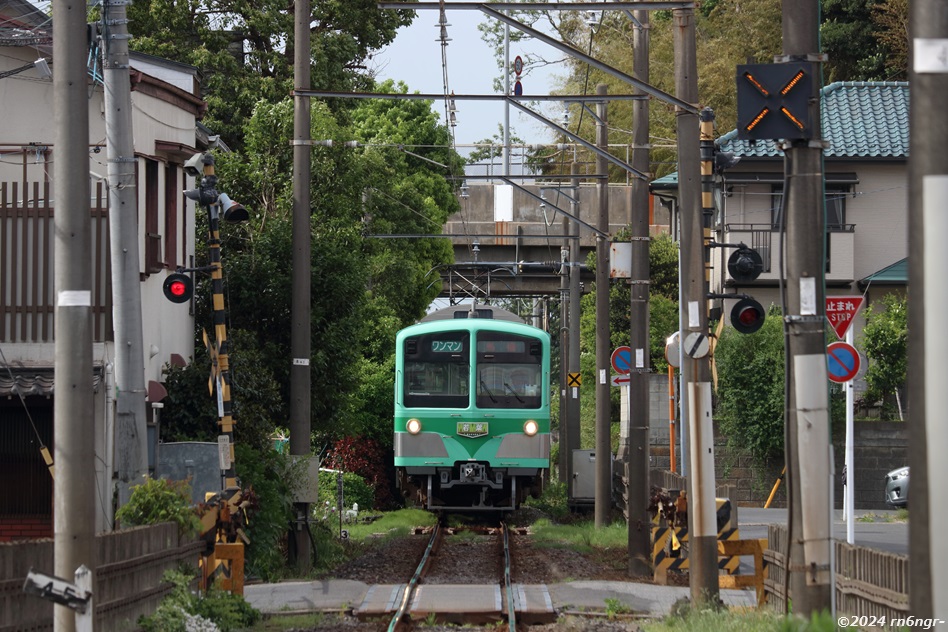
[859,294,908,417]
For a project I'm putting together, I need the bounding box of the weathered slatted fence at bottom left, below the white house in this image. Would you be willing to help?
[0,523,204,632]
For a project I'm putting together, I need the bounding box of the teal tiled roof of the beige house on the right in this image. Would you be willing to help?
[717,81,909,158]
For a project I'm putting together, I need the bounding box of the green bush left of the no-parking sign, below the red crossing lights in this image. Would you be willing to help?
[714,307,784,459]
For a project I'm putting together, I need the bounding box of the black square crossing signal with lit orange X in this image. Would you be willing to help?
[737,62,813,140]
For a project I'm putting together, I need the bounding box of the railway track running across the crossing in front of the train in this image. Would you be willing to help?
[388,522,525,632]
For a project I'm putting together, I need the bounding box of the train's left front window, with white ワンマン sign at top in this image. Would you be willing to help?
[403,332,470,408]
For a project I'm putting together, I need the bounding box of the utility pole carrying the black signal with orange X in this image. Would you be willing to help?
[783,0,833,618]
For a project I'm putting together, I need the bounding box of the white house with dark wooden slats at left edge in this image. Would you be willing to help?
[0,0,209,541]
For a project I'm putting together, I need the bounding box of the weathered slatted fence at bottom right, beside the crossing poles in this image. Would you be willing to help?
[764,525,909,621]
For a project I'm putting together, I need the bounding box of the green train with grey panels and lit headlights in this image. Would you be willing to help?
[394,305,550,512]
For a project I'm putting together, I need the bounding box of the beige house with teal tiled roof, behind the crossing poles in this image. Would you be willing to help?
[650,82,909,350]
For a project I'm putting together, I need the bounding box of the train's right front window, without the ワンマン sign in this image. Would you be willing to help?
[475,332,543,409]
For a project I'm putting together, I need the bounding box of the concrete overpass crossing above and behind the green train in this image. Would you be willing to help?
[438,181,668,300]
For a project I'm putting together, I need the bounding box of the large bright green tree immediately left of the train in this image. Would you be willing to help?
[165,92,462,446]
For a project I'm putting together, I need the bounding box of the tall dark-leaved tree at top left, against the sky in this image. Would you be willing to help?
[128,0,415,148]
